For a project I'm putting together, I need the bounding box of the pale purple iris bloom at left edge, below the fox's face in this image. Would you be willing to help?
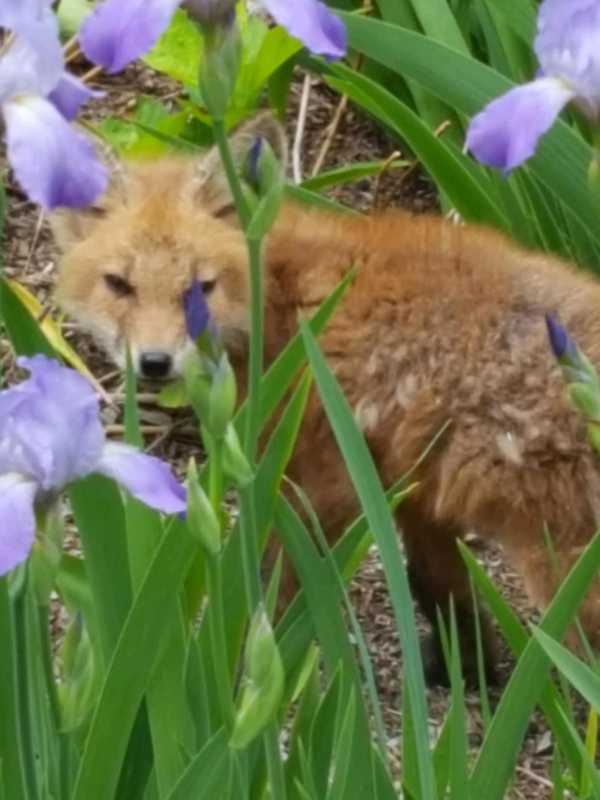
[0,355,186,575]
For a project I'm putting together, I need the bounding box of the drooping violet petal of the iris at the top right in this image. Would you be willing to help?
[465,78,574,173]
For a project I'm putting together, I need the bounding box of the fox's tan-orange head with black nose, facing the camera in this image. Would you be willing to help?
[52,114,285,379]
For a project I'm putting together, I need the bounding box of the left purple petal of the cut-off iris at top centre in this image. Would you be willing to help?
[79,0,181,73]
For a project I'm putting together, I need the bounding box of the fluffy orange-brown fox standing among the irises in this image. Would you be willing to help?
[52,114,600,684]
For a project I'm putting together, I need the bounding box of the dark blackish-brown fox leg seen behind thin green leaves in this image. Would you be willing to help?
[398,504,496,686]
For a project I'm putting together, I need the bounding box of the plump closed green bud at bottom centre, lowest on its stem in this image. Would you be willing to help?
[229,606,285,749]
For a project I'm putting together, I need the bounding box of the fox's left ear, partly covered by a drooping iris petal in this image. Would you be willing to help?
[49,148,125,253]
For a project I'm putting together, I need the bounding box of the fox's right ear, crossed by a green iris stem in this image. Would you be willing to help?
[195,111,287,216]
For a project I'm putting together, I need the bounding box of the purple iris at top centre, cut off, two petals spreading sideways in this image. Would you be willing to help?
[79,0,346,72]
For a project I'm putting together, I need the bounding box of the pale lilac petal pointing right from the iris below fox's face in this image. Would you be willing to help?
[96,442,186,514]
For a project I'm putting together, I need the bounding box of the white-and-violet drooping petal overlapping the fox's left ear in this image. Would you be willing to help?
[3,95,108,209]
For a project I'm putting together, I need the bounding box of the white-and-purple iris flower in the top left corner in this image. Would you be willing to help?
[0,0,107,209]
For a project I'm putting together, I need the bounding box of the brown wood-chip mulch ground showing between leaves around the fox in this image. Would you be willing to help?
[0,61,572,800]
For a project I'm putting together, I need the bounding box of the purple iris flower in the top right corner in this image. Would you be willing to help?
[465,0,600,173]
